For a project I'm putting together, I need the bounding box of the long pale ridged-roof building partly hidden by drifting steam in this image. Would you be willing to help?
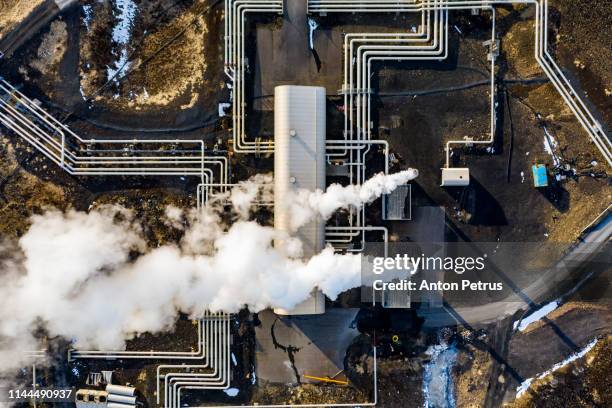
[274,85,326,315]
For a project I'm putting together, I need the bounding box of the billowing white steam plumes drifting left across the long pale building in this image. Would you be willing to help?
[0,170,417,369]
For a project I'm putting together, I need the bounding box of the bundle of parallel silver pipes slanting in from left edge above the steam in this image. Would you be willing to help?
[0,78,229,199]
